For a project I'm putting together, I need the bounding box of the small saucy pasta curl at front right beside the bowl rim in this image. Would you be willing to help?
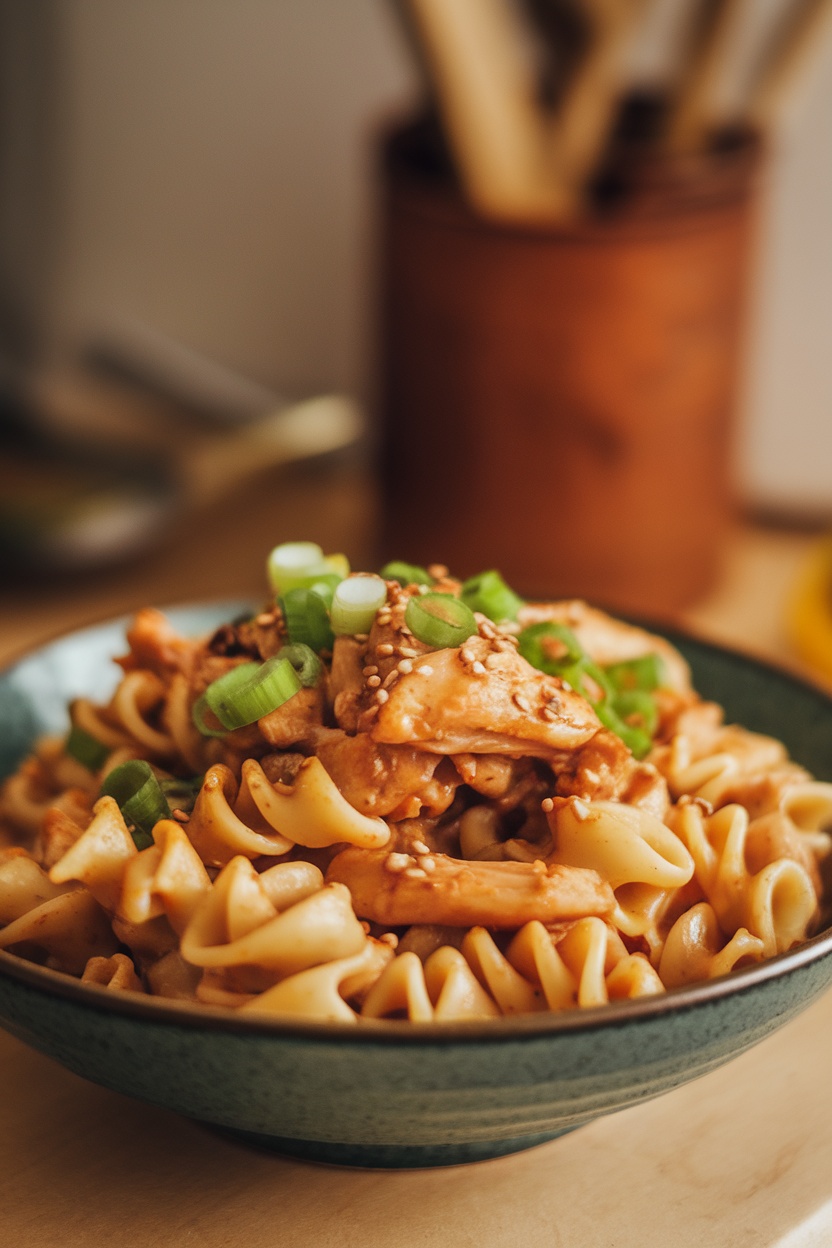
[659,901,763,988]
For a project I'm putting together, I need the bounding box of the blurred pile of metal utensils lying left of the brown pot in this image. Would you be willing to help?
[0,339,364,575]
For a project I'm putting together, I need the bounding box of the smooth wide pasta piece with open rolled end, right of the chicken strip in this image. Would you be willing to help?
[549,797,694,889]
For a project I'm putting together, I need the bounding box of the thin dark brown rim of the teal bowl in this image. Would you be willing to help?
[0,599,832,1046]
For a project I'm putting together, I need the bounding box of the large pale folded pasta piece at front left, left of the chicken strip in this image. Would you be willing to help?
[181,857,367,978]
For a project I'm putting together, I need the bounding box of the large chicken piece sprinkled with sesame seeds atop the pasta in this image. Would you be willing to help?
[359,636,600,761]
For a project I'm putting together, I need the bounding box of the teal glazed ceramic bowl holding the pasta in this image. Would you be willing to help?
[0,603,832,1168]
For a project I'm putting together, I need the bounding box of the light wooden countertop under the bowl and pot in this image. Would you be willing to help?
[0,464,832,1248]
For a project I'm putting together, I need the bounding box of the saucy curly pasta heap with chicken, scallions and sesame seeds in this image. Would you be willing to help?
[0,543,832,1023]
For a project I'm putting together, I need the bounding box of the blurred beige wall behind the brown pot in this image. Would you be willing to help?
[0,0,832,515]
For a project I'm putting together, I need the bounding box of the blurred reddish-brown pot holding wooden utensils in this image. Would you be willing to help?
[379,119,760,615]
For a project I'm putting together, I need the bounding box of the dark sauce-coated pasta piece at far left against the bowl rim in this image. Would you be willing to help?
[0,889,119,975]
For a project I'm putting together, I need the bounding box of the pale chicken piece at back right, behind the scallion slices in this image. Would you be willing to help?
[518,599,692,693]
